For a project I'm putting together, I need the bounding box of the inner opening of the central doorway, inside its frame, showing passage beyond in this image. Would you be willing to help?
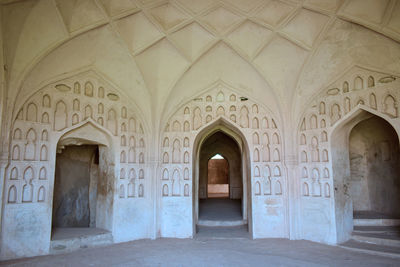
[199,131,244,226]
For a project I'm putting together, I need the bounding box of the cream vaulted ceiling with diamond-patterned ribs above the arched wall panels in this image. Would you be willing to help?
[2,0,400,126]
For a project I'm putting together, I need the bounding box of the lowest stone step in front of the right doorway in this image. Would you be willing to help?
[339,239,400,258]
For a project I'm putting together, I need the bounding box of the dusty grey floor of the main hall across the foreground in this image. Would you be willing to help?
[0,229,400,267]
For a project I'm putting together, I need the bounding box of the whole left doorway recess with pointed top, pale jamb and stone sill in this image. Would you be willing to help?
[50,123,114,249]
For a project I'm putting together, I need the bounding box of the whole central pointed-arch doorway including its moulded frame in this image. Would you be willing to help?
[193,119,251,233]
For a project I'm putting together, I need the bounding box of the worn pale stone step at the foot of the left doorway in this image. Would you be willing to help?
[50,230,114,254]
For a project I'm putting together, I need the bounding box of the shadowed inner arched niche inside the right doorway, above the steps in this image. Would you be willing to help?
[349,116,400,219]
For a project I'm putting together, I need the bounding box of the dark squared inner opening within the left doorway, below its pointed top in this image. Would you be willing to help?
[52,145,99,240]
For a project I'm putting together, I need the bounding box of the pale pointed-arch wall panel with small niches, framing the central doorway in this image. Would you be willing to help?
[158,84,288,238]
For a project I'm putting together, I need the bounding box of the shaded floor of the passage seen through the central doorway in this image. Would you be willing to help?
[199,198,242,221]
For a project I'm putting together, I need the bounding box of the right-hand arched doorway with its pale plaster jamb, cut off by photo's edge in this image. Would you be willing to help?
[331,109,400,243]
